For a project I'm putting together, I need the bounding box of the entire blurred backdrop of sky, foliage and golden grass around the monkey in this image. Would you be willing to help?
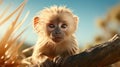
[0,0,120,67]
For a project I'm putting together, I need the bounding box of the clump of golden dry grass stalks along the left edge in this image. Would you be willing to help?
[0,0,29,67]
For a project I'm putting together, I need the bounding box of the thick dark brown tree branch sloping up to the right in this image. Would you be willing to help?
[61,35,120,67]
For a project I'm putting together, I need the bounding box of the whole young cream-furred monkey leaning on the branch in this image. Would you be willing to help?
[23,6,79,64]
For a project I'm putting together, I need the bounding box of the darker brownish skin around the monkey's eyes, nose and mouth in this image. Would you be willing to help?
[47,18,67,42]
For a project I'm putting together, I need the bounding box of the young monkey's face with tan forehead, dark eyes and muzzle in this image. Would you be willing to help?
[46,13,75,42]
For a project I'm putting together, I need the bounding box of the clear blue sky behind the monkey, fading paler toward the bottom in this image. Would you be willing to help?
[1,0,120,46]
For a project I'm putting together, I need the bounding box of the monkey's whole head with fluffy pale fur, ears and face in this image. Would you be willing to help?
[33,6,78,43]
